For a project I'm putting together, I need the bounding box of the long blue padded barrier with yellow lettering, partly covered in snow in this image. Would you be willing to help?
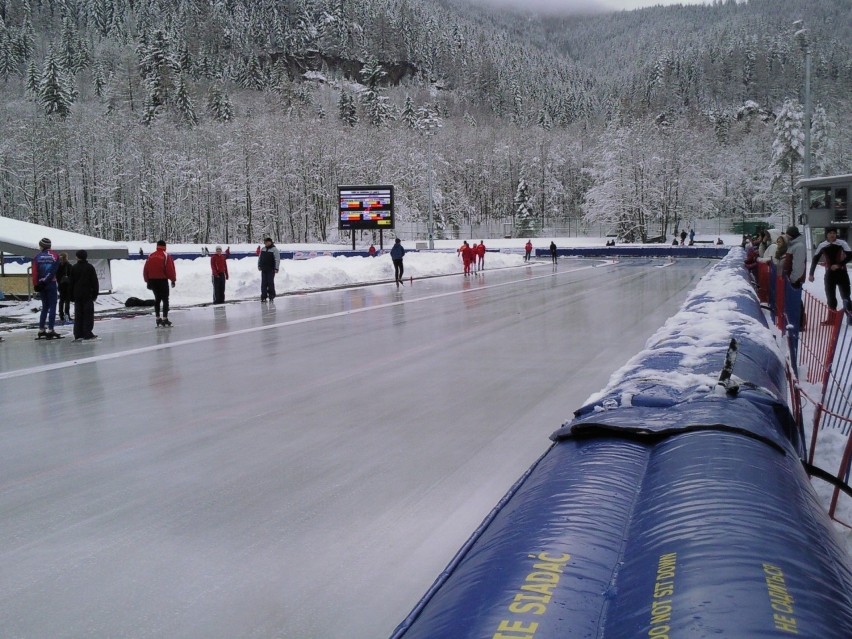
[392,250,852,639]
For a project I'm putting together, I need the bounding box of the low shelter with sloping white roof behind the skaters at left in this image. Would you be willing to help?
[0,217,129,297]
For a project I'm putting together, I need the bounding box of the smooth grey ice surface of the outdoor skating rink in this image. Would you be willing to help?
[0,259,722,639]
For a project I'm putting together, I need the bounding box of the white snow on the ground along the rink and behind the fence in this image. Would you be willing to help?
[0,233,852,554]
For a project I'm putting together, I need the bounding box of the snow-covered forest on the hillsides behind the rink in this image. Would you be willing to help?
[0,0,852,243]
